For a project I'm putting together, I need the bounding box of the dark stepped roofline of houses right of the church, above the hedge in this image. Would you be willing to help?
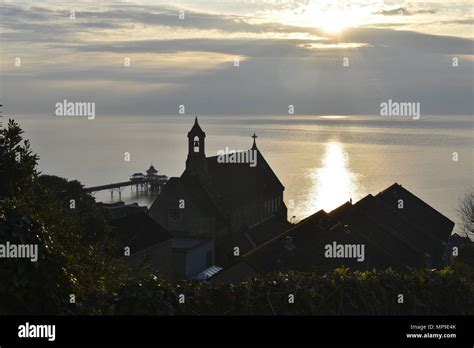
[213,184,453,281]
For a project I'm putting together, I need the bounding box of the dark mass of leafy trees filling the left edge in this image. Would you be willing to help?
[0,120,139,315]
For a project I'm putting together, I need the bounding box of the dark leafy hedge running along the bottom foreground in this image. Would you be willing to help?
[107,268,474,315]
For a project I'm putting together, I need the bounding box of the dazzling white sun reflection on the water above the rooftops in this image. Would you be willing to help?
[307,141,359,214]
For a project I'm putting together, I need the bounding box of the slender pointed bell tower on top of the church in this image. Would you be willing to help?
[186,116,207,175]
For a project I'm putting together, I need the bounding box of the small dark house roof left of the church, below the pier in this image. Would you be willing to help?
[112,212,172,254]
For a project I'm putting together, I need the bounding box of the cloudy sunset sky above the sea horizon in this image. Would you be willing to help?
[0,0,474,117]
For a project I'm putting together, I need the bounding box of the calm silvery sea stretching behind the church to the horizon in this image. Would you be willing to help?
[12,115,474,232]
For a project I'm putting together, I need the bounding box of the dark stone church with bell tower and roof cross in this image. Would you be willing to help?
[149,117,289,265]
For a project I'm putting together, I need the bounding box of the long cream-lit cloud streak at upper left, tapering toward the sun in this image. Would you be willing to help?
[0,4,322,42]
